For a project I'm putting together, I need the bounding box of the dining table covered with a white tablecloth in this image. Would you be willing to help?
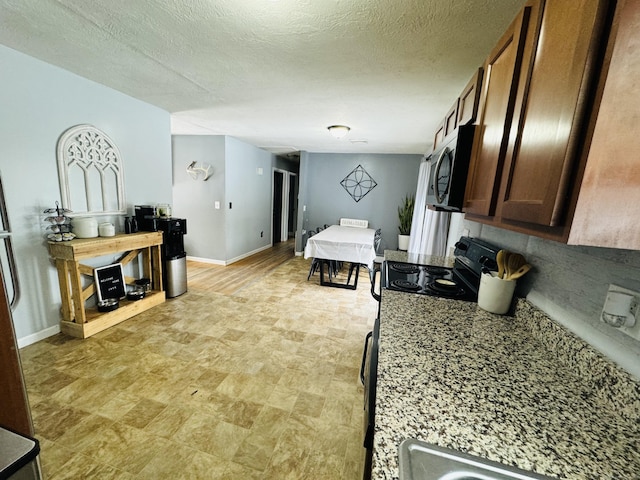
[304,225,376,289]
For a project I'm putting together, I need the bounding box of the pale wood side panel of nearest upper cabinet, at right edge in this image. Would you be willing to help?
[569,0,640,250]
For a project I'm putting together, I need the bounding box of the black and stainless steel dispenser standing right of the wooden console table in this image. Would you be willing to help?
[156,218,187,298]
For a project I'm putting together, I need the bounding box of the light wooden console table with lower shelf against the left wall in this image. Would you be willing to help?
[49,232,165,338]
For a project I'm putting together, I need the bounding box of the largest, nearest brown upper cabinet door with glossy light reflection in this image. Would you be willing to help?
[501,0,610,226]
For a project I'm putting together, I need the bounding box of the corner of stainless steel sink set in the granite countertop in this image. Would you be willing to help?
[398,438,550,480]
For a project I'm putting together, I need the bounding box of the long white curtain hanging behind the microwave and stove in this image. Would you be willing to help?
[408,158,451,258]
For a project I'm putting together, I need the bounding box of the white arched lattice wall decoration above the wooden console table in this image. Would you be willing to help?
[57,125,127,215]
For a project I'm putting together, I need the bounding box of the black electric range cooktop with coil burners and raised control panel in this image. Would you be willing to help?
[382,237,500,302]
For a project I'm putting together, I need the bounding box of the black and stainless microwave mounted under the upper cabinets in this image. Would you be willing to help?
[427,125,475,212]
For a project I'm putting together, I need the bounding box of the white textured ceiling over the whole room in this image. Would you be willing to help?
[0,0,524,153]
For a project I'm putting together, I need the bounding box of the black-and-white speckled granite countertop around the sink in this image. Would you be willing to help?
[372,286,640,480]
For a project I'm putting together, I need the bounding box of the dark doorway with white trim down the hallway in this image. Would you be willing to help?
[271,168,298,245]
